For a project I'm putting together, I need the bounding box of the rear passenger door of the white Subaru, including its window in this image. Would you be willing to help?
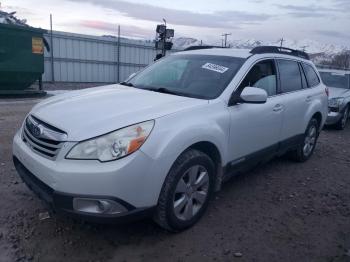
[277,59,313,148]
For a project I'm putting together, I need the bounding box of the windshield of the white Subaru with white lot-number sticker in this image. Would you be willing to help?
[126,54,245,99]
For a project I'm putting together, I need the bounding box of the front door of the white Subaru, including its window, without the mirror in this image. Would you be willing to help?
[229,59,283,165]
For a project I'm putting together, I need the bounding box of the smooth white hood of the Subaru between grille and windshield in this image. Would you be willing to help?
[30,84,208,141]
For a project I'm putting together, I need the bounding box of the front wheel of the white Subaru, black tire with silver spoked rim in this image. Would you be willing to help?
[154,149,215,232]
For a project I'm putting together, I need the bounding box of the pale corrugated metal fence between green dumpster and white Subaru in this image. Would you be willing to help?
[43,31,175,83]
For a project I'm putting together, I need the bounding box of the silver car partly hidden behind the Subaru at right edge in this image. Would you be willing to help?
[319,69,350,130]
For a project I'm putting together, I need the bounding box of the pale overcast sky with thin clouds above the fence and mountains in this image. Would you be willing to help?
[0,0,350,46]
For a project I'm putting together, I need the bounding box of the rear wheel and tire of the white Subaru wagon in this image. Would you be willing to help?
[290,118,320,162]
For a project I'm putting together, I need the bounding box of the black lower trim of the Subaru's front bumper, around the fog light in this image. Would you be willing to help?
[13,157,154,223]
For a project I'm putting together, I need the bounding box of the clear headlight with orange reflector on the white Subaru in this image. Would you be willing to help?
[66,120,154,162]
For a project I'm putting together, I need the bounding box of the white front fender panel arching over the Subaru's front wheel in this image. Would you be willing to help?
[141,102,229,199]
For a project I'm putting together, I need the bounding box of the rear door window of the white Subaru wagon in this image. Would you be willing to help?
[278,60,302,93]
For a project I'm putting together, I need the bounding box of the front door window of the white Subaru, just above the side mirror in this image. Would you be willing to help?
[240,60,277,96]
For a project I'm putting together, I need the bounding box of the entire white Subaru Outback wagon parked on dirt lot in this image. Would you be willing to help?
[13,47,328,231]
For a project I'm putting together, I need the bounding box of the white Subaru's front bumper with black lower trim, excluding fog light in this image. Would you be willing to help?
[13,131,167,220]
